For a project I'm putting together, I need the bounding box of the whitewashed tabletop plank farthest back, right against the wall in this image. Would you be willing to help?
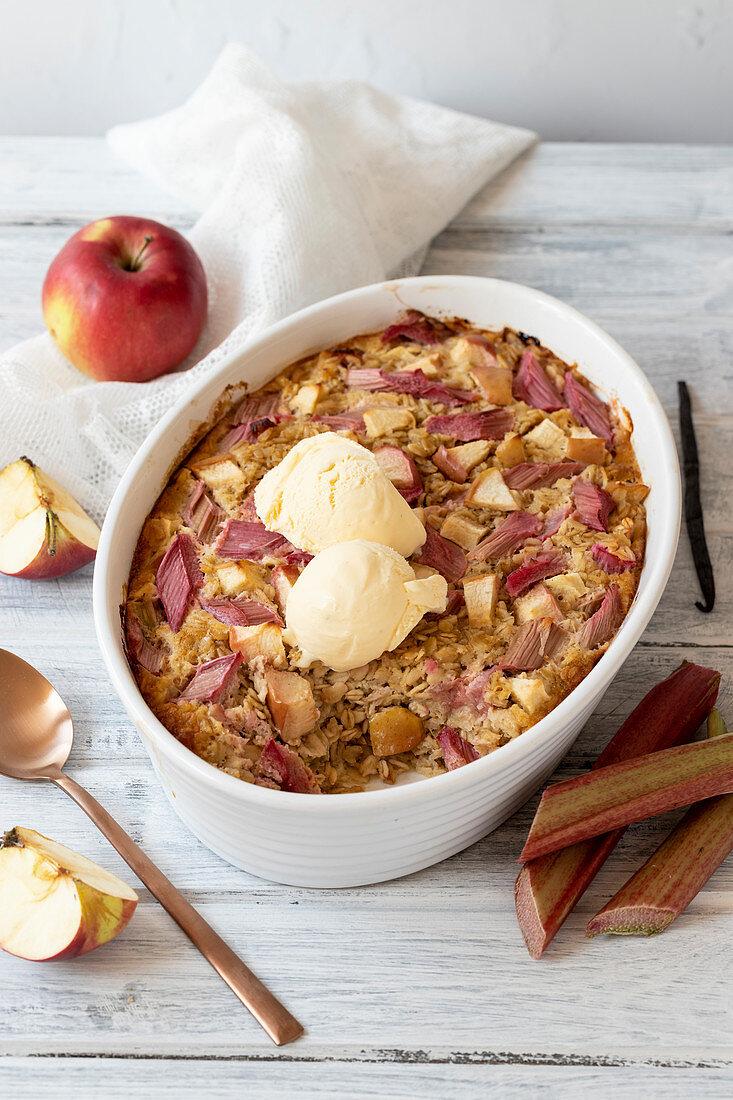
[0,138,733,229]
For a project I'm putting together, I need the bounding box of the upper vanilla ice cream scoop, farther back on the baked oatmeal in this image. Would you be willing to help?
[254,431,426,558]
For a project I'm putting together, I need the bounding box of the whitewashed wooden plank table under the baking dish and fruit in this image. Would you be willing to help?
[0,139,733,1100]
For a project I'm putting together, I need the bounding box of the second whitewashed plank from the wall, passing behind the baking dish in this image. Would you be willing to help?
[7,209,733,350]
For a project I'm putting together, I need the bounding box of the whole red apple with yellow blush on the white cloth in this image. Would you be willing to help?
[42,216,207,382]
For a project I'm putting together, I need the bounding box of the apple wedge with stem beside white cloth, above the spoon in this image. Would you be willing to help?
[0,458,99,580]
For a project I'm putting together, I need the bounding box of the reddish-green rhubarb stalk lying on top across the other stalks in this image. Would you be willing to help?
[519,734,733,862]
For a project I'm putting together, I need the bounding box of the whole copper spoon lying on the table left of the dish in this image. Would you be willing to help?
[0,649,303,1046]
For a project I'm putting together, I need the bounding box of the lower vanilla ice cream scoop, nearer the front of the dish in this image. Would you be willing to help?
[286,539,448,672]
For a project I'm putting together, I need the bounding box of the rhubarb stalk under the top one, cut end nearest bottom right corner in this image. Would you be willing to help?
[586,710,733,936]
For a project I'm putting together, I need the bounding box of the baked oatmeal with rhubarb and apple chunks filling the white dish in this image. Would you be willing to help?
[123,311,648,793]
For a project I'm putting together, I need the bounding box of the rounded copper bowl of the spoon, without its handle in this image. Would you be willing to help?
[0,649,74,779]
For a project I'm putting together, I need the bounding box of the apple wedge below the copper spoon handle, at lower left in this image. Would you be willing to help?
[0,827,138,963]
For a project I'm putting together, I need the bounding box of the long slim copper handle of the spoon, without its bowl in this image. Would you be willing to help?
[50,772,303,1046]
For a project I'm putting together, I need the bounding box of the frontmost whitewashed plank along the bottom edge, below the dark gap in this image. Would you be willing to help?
[0,1058,733,1100]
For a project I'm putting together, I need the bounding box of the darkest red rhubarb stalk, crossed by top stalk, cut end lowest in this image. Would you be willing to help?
[514,661,720,958]
